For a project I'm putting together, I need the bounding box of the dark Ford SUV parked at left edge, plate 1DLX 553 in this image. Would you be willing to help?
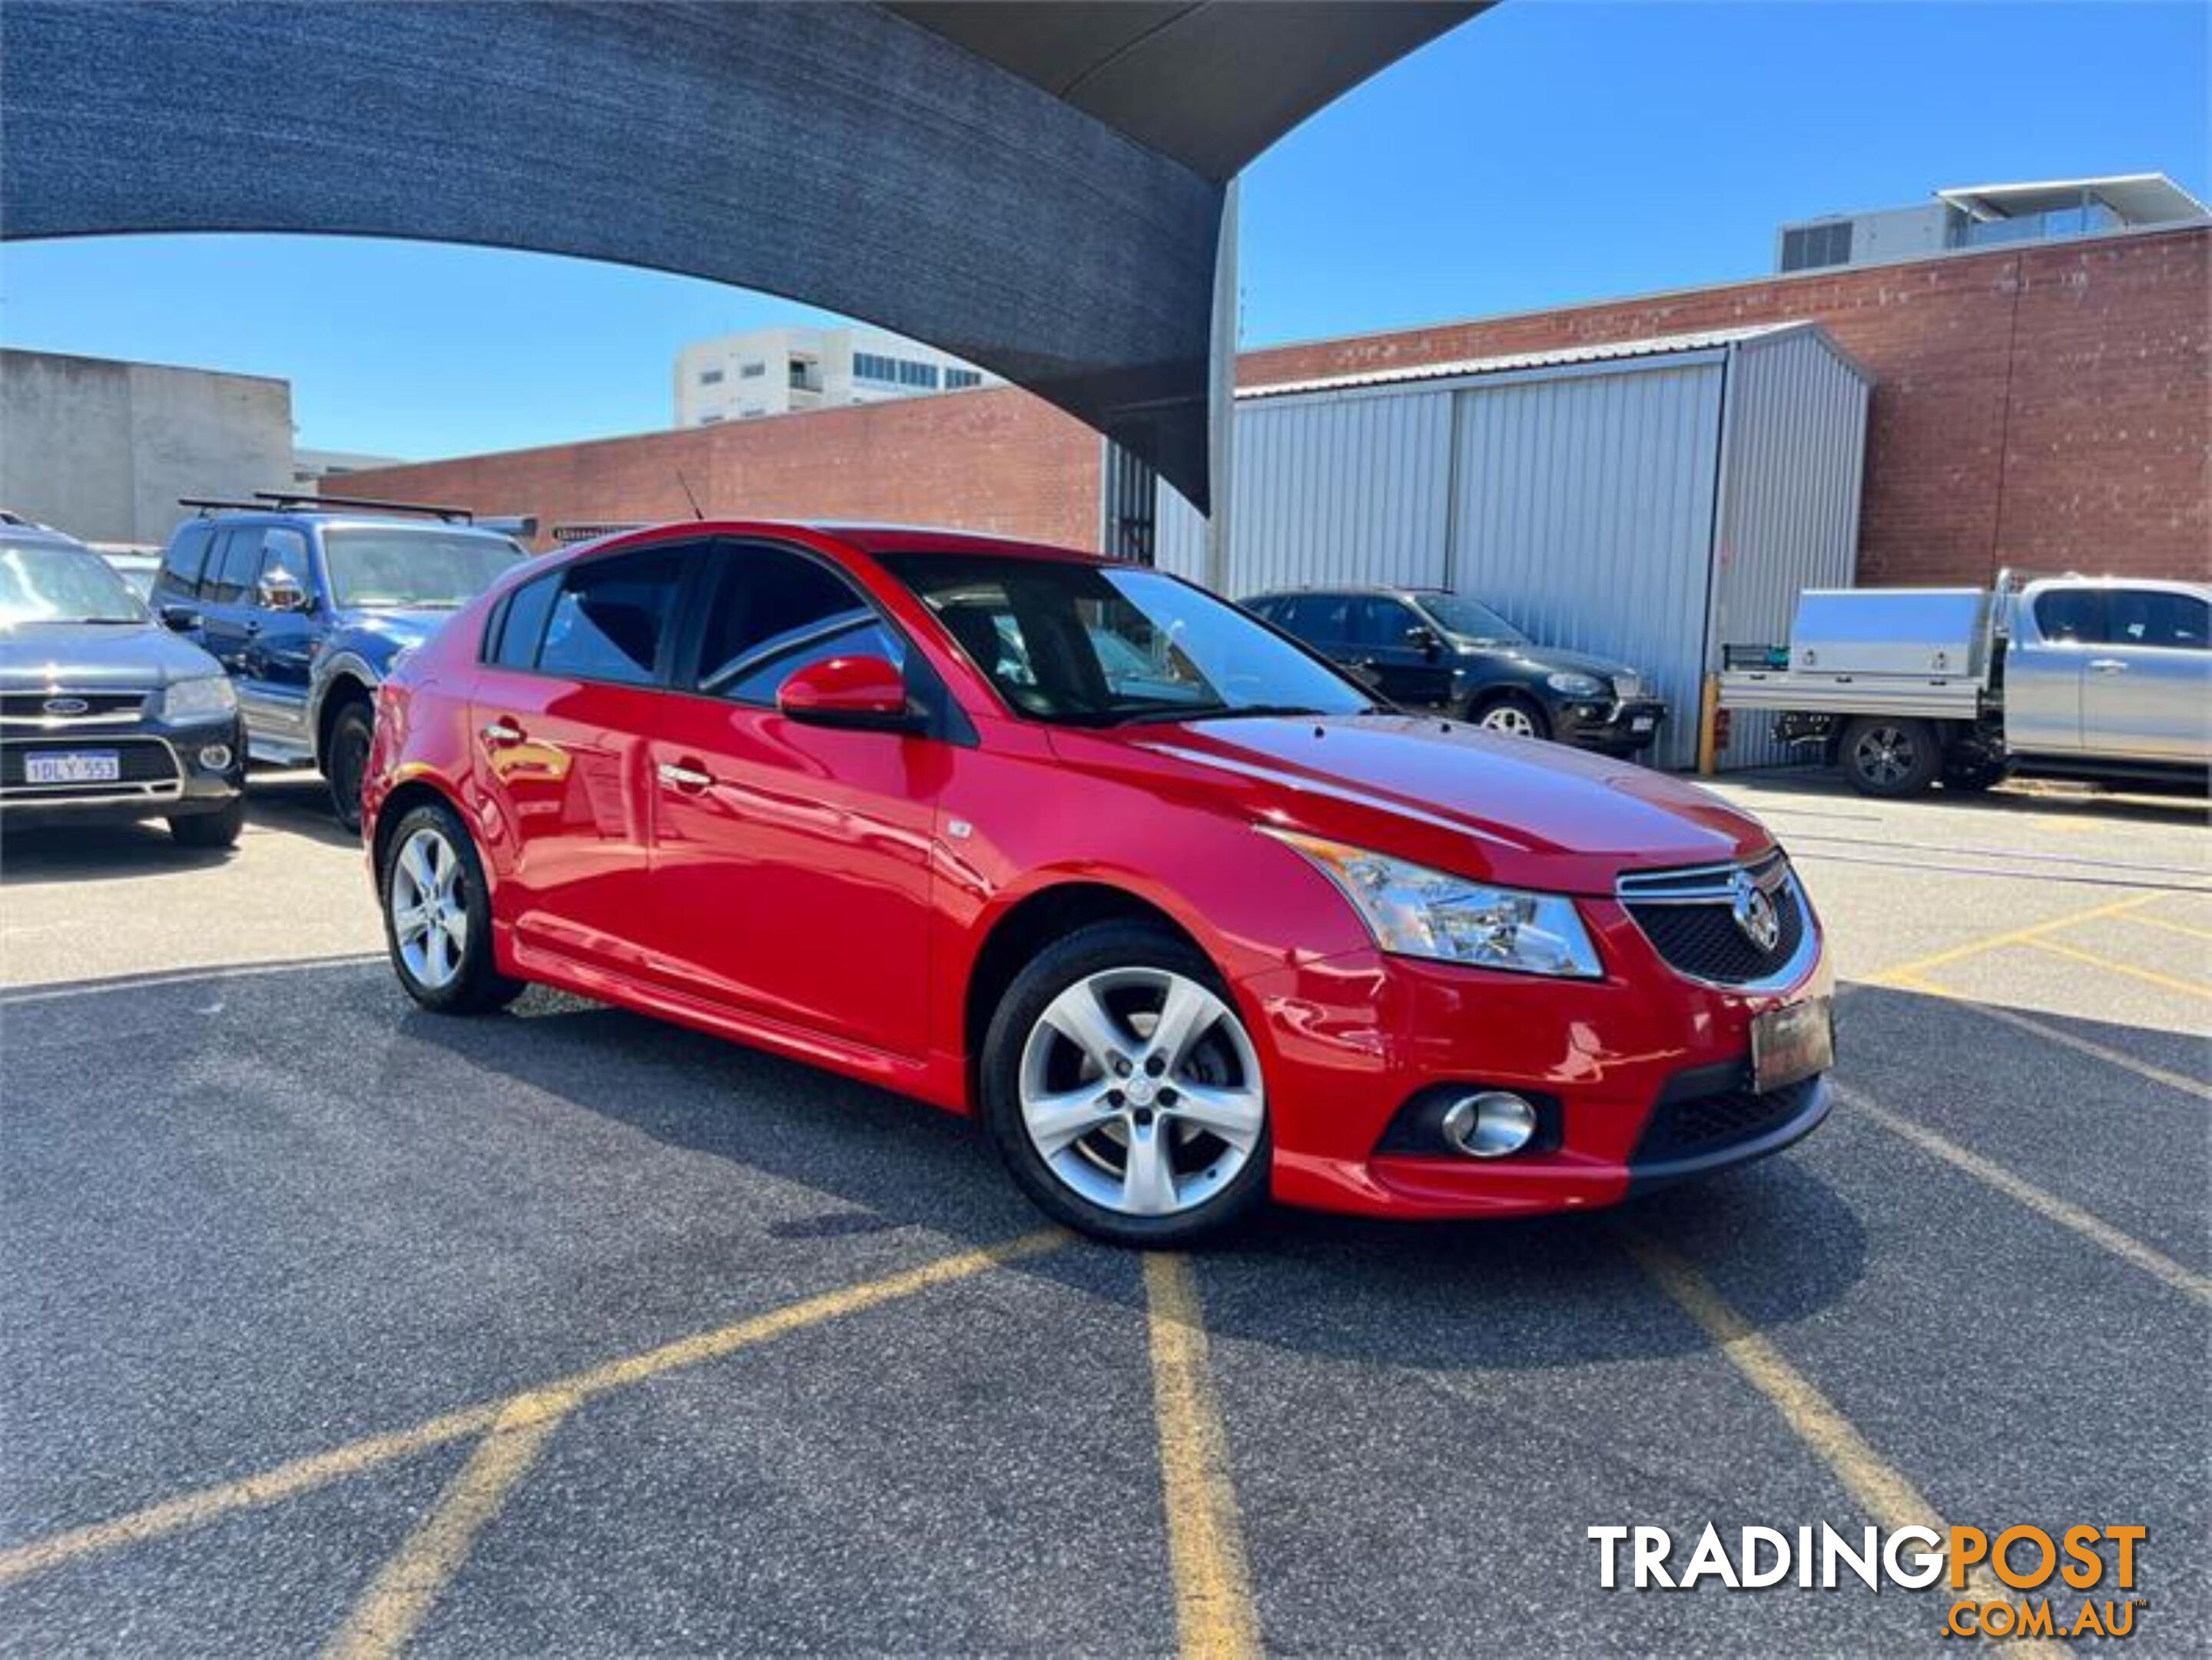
[0,525,246,848]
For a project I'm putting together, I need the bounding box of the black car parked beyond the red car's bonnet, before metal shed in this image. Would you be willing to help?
[1243,589,1666,755]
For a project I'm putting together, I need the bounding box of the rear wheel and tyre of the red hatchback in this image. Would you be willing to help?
[376,803,522,1014]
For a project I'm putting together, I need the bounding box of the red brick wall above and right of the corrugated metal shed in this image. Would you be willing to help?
[1239,228,2212,584]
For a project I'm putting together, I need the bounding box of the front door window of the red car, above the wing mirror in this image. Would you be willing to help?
[697,546,907,704]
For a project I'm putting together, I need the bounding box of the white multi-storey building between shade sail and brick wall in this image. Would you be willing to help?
[675,327,1004,427]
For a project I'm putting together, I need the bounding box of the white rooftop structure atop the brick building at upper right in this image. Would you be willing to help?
[1774,173,2212,272]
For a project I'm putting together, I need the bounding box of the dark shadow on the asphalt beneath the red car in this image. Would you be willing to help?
[403,989,1867,1368]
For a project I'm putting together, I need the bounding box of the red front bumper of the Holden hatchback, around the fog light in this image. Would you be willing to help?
[1239,901,1834,1217]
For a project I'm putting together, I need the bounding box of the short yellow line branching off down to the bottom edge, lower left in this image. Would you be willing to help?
[325,1393,577,1660]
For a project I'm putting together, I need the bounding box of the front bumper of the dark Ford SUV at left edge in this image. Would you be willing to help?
[0,715,246,825]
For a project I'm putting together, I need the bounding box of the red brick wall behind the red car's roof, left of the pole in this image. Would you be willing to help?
[327,387,1099,549]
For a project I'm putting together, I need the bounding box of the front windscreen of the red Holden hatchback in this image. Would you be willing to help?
[883,553,1374,726]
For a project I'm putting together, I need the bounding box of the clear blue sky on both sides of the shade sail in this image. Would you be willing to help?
[0,0,2212,458]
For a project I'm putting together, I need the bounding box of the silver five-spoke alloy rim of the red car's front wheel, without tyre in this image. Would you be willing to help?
[1020,968,1268,1217]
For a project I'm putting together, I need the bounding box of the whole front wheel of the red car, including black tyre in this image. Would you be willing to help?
[980,923,1270,1246]
